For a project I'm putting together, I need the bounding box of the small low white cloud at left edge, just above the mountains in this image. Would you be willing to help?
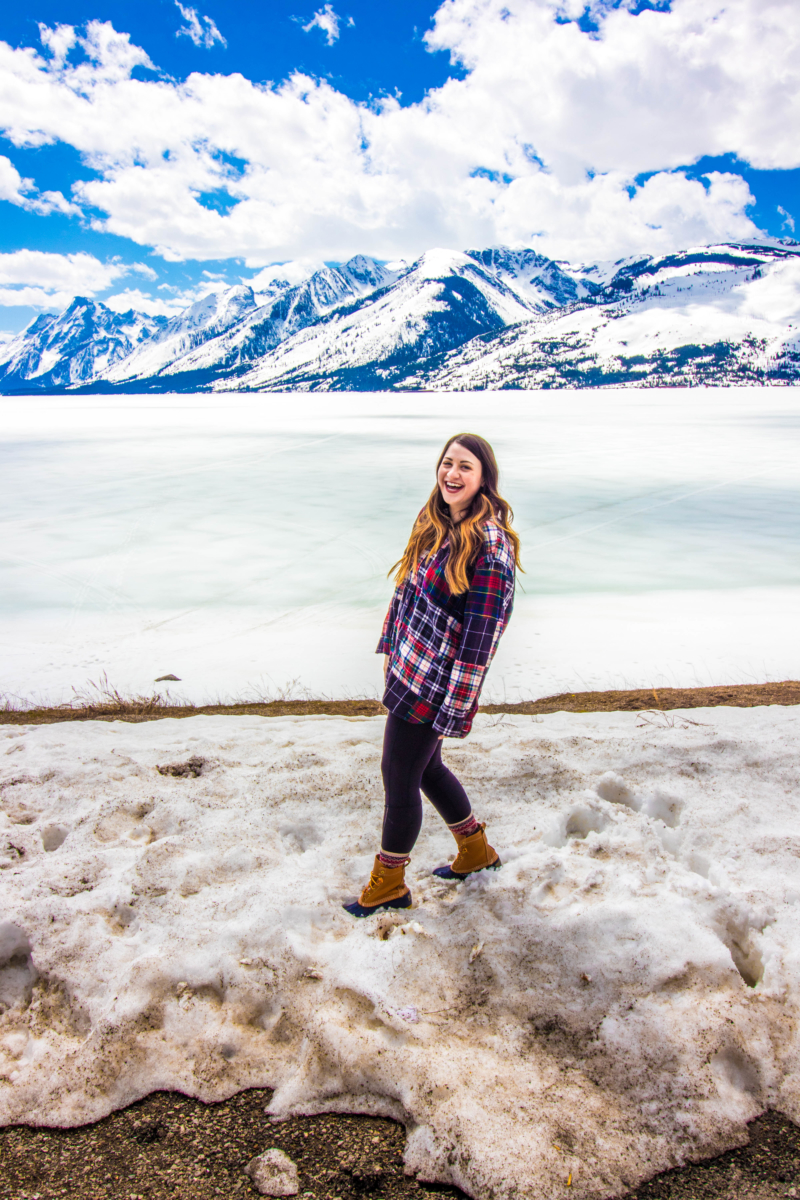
[0,250,156,308]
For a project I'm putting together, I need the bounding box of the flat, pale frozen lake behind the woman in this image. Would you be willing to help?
[0,388,800,701]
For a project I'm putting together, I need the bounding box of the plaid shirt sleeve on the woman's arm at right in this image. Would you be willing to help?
[433,552,515,738]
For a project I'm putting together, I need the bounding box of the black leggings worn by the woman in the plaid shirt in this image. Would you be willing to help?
[380,713,473,854]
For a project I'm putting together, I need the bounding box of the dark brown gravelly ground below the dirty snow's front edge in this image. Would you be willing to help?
[0,1091,800,1200]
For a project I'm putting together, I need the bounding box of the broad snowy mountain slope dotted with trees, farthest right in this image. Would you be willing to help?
[403,246,800,390]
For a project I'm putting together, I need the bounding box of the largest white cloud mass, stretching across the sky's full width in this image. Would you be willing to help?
[0,0,800,270]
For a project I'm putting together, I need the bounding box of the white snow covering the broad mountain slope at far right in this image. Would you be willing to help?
[412,246,800,390]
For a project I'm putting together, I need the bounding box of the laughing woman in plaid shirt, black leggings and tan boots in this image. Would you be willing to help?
[344,433,519,917]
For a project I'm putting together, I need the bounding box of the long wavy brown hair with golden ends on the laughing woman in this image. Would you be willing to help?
[389,433,522,595]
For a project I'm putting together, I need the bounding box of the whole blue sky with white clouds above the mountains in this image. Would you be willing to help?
[0,0,800,330]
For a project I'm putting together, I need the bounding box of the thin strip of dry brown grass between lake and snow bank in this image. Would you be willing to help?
[0,679,800,725]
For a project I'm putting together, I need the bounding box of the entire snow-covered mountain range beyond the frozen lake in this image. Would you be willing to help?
[0,240,800,395]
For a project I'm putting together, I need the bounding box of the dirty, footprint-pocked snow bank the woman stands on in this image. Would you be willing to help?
[0,708,800,1198]
